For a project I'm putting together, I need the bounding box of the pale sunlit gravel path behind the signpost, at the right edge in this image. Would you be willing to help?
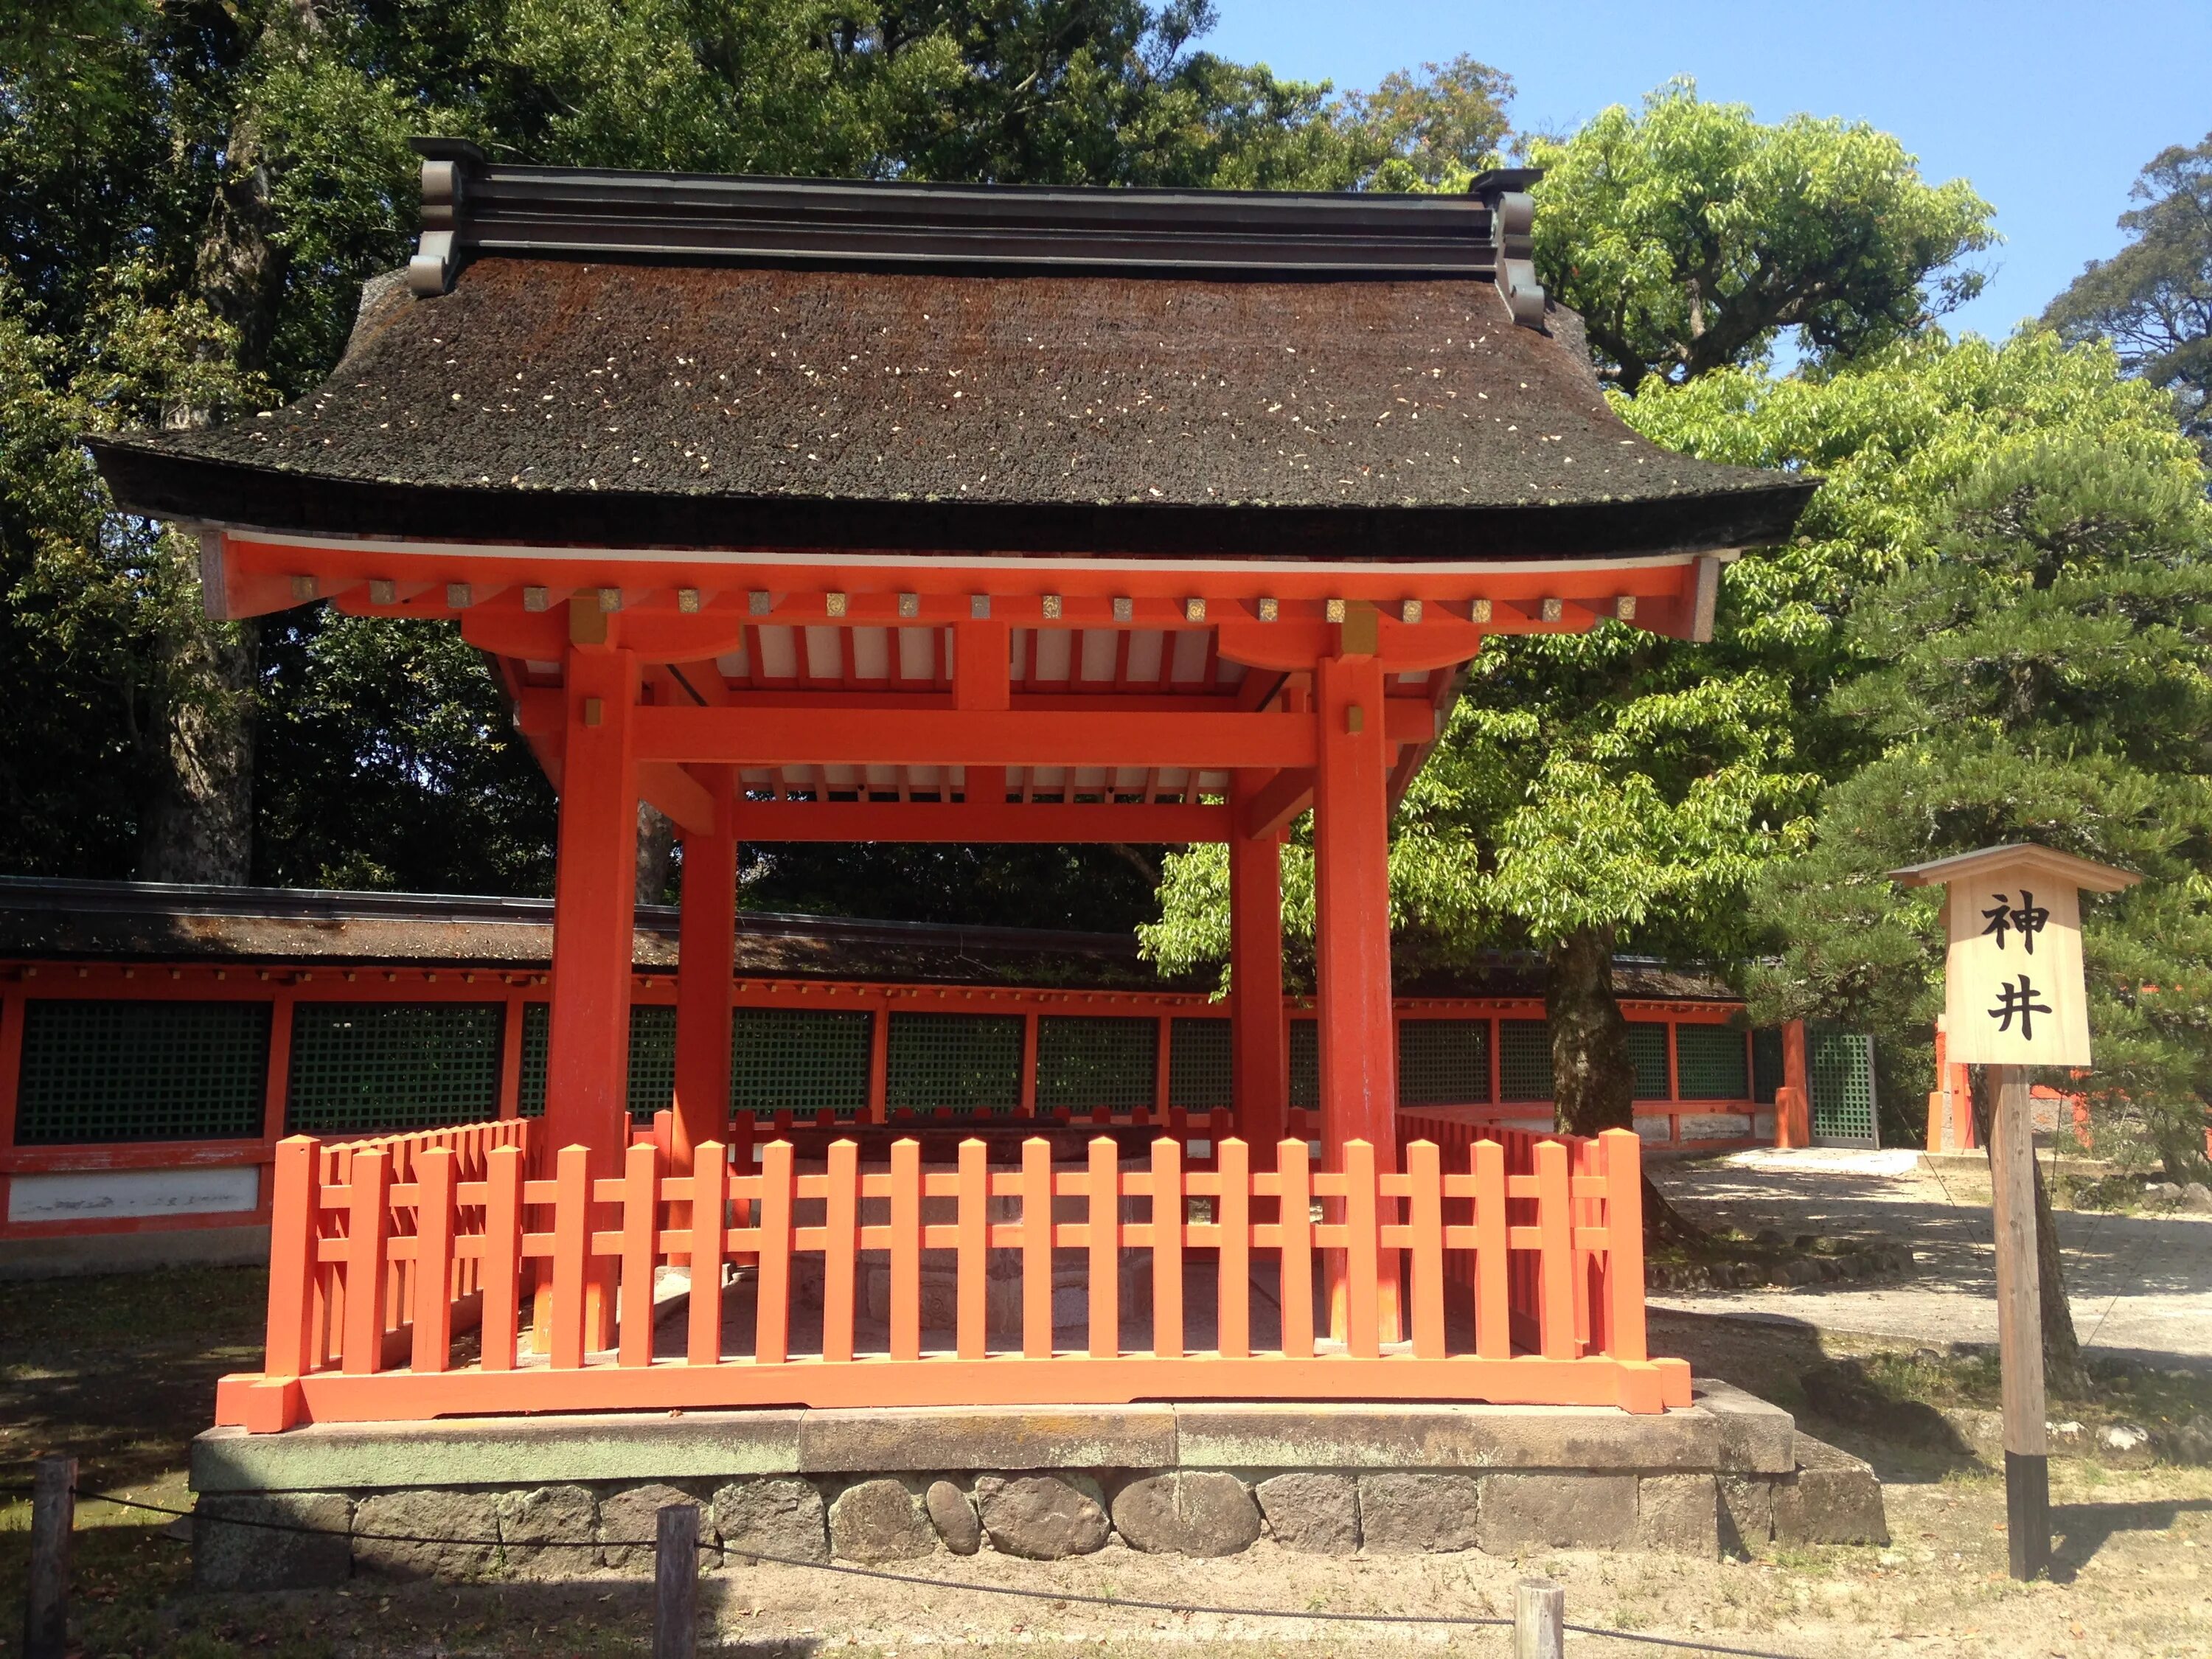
[1652,1150,2212,1360]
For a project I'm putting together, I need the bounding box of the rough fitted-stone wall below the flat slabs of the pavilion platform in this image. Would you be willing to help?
[192,1436,1887,1590]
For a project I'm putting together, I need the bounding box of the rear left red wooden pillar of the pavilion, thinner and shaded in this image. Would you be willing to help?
[668,768,737,1175]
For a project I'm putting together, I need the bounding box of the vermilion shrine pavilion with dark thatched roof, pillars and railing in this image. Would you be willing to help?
[95,139,1814,1429]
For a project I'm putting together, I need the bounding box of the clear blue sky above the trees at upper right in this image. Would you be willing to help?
[1203,0,2212,347]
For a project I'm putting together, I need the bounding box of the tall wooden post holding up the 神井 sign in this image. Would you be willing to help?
[1989,1066,2051,1579]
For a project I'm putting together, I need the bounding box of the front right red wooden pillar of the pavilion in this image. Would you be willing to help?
[1314,641,1398,1343]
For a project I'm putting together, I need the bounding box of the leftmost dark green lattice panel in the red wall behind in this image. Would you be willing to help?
[15,998,270,1146]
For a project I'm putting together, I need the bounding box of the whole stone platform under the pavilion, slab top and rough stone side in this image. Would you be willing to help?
[192,1380,1887,1590]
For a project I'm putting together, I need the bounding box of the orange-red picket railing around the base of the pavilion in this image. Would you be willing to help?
[217,1124,1690,1431]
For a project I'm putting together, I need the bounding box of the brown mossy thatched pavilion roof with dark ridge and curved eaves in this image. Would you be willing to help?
[95,164,1814,560]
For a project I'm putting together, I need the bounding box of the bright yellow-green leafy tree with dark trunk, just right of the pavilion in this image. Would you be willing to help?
[1146,334,2185,1128]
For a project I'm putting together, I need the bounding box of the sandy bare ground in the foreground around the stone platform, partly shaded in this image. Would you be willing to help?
[0,1265,2212,1659]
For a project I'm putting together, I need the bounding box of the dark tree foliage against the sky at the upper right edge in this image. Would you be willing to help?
[2044,133,2212,453]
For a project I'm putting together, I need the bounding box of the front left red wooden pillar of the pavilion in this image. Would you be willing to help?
[544,648,637,1349]
